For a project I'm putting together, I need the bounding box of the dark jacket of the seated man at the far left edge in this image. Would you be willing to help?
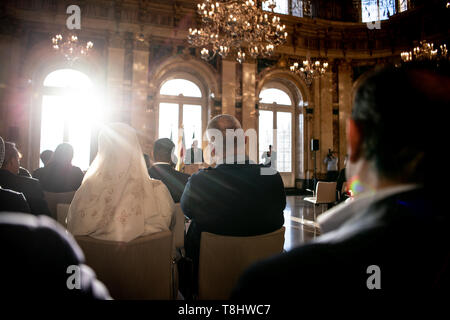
[0,169,50,216]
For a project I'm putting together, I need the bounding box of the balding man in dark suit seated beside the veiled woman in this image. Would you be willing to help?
[181,115,286,296]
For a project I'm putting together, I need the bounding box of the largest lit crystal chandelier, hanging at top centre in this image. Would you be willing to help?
[188,0,288,63]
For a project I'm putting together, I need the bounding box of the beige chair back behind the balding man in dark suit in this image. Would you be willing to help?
[199,227,285,300]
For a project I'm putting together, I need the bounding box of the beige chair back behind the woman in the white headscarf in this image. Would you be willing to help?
[75,231,174,300]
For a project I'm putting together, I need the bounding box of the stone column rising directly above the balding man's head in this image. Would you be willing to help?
[222,60,236,116]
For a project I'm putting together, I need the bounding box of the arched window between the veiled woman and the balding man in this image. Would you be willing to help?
[158,78,205,148]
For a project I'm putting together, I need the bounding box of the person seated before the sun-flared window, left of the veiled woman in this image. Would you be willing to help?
[36,143,83,192]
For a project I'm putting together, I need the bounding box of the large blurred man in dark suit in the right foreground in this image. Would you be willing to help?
[232,63,450,303]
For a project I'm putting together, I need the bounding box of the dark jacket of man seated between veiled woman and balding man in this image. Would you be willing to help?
[148,163,189,202]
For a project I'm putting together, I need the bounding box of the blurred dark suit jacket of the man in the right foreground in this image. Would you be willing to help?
[232,190,450,304]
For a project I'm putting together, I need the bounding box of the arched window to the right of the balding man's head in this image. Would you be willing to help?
[258,83,295,173]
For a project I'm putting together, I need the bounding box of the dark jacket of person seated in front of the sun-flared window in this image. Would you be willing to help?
[33,163,84,192]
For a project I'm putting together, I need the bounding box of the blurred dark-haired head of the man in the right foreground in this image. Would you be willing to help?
[347,63,450,189]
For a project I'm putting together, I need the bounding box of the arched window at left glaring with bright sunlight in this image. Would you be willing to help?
[40,69,100,170]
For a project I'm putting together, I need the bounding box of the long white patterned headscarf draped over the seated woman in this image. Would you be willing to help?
[67,123,174,242]
